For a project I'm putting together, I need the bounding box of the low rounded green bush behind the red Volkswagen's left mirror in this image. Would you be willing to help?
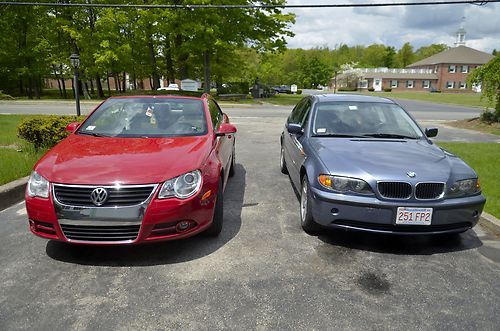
[17,115,84,149]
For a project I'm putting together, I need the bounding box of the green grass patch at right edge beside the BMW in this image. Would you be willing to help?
[438,142,500,218]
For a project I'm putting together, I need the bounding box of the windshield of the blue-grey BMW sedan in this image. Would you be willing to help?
[313,102,422,139]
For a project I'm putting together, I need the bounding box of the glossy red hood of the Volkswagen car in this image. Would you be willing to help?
[35,134,212,185]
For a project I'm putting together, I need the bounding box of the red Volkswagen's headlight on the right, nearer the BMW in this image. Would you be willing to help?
[158,170,201,199]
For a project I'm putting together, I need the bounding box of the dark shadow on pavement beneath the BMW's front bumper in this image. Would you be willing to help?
[318,230,483,255]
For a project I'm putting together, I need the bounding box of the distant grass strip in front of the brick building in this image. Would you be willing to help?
[363,92,494,108]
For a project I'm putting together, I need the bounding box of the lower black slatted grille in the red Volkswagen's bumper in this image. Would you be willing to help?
[61,224,141,242]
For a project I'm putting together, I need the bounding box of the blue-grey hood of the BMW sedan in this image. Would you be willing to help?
[311,138,475,181]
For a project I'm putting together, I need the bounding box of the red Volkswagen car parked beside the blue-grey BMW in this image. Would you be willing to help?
[26,94,236,245]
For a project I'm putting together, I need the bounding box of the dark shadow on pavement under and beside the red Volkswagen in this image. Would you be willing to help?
[46,164,246,267]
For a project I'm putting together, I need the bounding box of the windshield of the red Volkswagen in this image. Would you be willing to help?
[77,98,207,138]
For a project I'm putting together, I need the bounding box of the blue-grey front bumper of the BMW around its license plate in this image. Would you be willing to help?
[310,187,486,235]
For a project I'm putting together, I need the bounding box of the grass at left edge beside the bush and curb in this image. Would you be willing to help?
[0,115,45,185]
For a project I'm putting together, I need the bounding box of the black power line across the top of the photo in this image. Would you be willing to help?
[0,0,500,9]
